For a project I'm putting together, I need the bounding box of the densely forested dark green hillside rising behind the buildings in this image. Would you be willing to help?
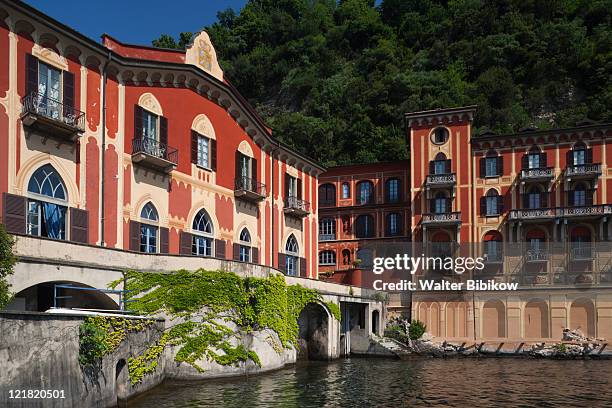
[153,0,612,165]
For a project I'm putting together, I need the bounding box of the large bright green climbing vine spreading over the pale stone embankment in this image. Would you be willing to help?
[103,269,340,385]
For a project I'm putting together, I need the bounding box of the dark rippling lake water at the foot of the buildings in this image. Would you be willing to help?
[129,358,612,408]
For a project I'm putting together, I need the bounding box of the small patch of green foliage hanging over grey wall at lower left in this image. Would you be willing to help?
[79,316,154,366]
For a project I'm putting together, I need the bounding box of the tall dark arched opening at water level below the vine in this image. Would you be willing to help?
[298,303,329,360]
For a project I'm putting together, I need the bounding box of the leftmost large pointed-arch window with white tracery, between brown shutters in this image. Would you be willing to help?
[27,164,68,239]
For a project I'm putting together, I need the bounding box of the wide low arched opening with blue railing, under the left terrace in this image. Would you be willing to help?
[5,281,119,312]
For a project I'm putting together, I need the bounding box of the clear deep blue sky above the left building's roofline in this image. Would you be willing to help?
[25,0,246,45]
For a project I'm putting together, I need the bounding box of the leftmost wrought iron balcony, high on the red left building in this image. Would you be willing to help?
[21,92,85,141]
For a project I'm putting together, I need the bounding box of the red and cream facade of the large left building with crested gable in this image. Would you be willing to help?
[0,1,323,310]
